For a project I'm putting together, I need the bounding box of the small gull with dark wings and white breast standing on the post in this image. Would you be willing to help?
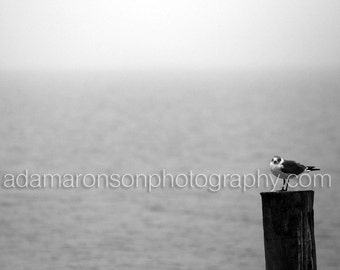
[269,156,320,191]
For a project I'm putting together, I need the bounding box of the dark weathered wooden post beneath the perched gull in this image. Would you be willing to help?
[261,190,316,270]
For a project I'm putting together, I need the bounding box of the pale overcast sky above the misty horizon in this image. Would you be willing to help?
[0,0,340,69]
